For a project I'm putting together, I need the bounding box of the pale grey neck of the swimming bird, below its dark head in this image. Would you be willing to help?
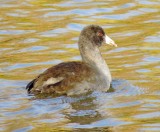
[79,40,112,87]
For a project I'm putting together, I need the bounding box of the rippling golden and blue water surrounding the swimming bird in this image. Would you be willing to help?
[0,0,160,132]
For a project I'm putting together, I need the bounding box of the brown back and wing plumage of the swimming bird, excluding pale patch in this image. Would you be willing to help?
[27,62,94,94]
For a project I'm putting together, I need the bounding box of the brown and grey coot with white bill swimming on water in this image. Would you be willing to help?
[26,25,117,95]
